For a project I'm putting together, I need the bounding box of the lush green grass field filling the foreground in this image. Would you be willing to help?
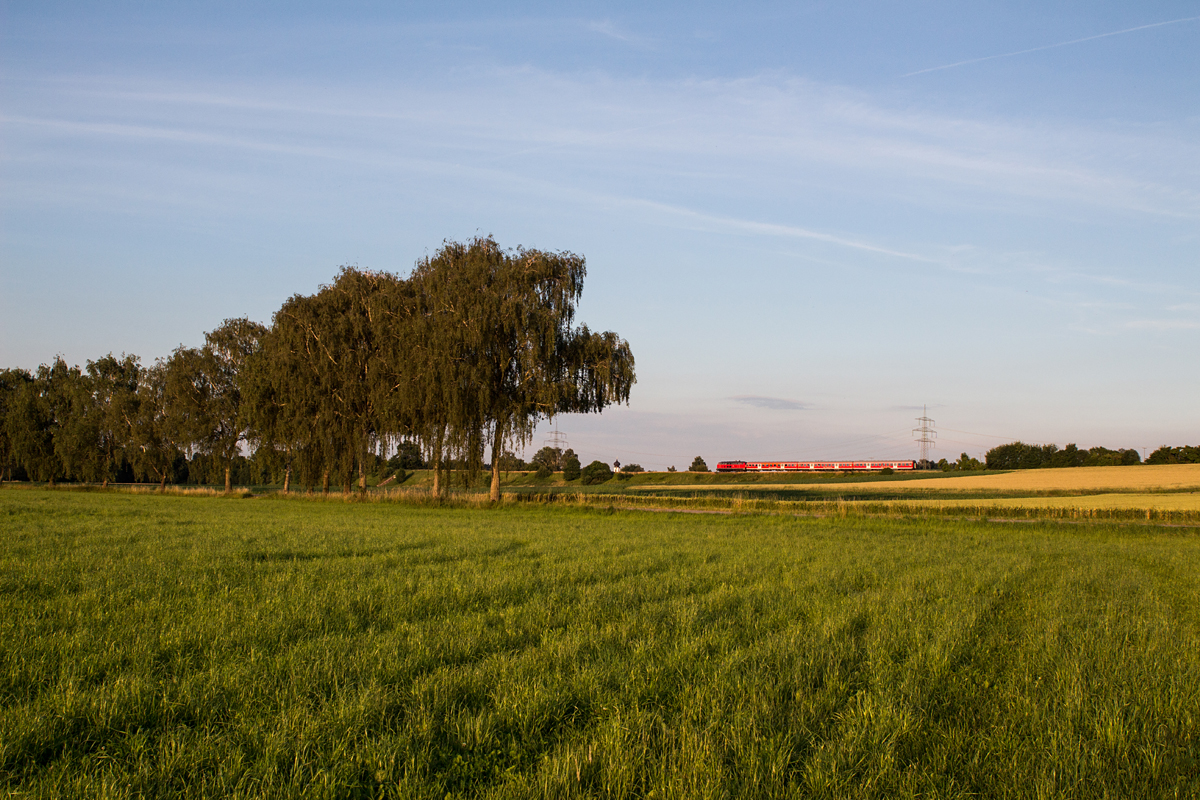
[0,491,1200,798]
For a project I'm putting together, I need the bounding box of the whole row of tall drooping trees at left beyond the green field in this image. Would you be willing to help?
[0,237,636,497]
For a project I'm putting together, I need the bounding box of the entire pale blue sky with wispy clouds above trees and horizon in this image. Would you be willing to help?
[0,0,1200,469]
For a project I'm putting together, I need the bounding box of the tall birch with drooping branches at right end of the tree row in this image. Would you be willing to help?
[414,236,635,500]
